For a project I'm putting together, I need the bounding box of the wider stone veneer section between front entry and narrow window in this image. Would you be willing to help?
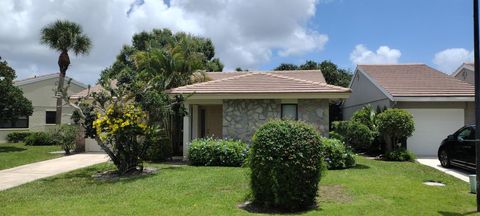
[223,99,281,142]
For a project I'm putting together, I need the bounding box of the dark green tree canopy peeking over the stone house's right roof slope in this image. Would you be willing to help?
[274,60,352,87]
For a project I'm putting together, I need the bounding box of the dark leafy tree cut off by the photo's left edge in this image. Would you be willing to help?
[0,57,33,121]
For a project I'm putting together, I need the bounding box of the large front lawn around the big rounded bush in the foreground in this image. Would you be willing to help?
[0,157,475,215]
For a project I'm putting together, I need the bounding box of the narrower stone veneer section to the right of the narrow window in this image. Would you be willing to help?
[298,99,329,137]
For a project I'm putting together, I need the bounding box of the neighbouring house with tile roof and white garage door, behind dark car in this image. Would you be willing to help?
[343,64,475,155]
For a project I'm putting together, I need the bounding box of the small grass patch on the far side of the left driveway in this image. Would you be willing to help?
[0,143,63,170]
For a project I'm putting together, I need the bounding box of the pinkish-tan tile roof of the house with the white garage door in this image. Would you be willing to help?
[357,64,475,97]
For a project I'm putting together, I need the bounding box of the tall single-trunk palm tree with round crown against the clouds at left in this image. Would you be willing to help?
[40,20,92,125]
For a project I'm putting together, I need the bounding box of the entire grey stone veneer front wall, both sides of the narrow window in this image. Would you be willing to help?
[223,99,329,142]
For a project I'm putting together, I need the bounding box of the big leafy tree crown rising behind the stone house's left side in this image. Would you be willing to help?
[101,29,223,81]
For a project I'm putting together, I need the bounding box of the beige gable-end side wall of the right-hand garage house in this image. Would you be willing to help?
[343,71,392,120]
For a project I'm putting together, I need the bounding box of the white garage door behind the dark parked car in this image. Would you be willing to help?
[406,109,464,156]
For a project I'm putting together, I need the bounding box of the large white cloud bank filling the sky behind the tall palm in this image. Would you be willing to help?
[0,0,328,83]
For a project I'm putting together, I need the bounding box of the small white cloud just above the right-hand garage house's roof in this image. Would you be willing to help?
[433,48,473,74]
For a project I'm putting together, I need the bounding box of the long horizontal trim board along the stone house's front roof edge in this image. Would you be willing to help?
[182,92,350,101]
